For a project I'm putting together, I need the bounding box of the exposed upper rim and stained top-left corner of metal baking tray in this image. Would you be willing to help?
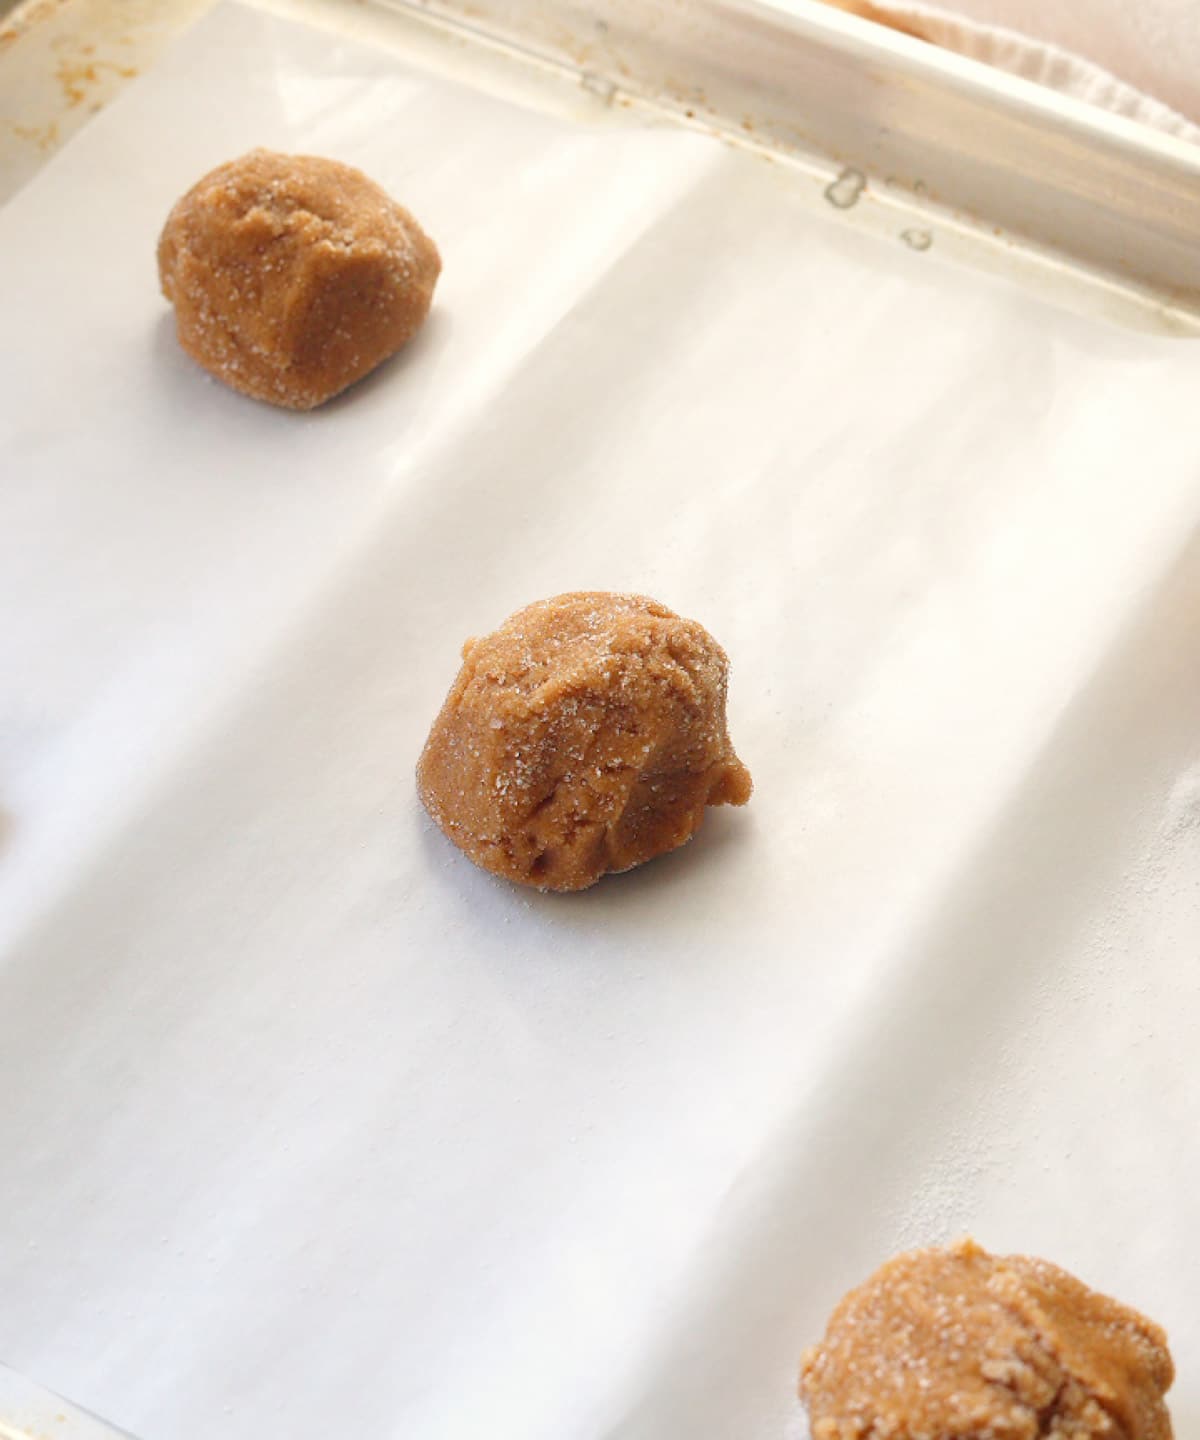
[0,0,1200,325]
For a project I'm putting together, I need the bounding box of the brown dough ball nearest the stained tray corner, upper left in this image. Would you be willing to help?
[158,150,441,410]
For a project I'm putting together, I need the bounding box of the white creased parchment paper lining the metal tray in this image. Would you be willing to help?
[0,6,1200,1440]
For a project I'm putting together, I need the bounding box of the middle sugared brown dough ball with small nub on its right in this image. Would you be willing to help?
[416,592,751,890]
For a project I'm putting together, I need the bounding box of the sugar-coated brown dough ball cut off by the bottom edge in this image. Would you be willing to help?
[800,1240,1174,1440]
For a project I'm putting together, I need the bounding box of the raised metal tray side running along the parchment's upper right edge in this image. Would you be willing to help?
[409,0,1200,333]
